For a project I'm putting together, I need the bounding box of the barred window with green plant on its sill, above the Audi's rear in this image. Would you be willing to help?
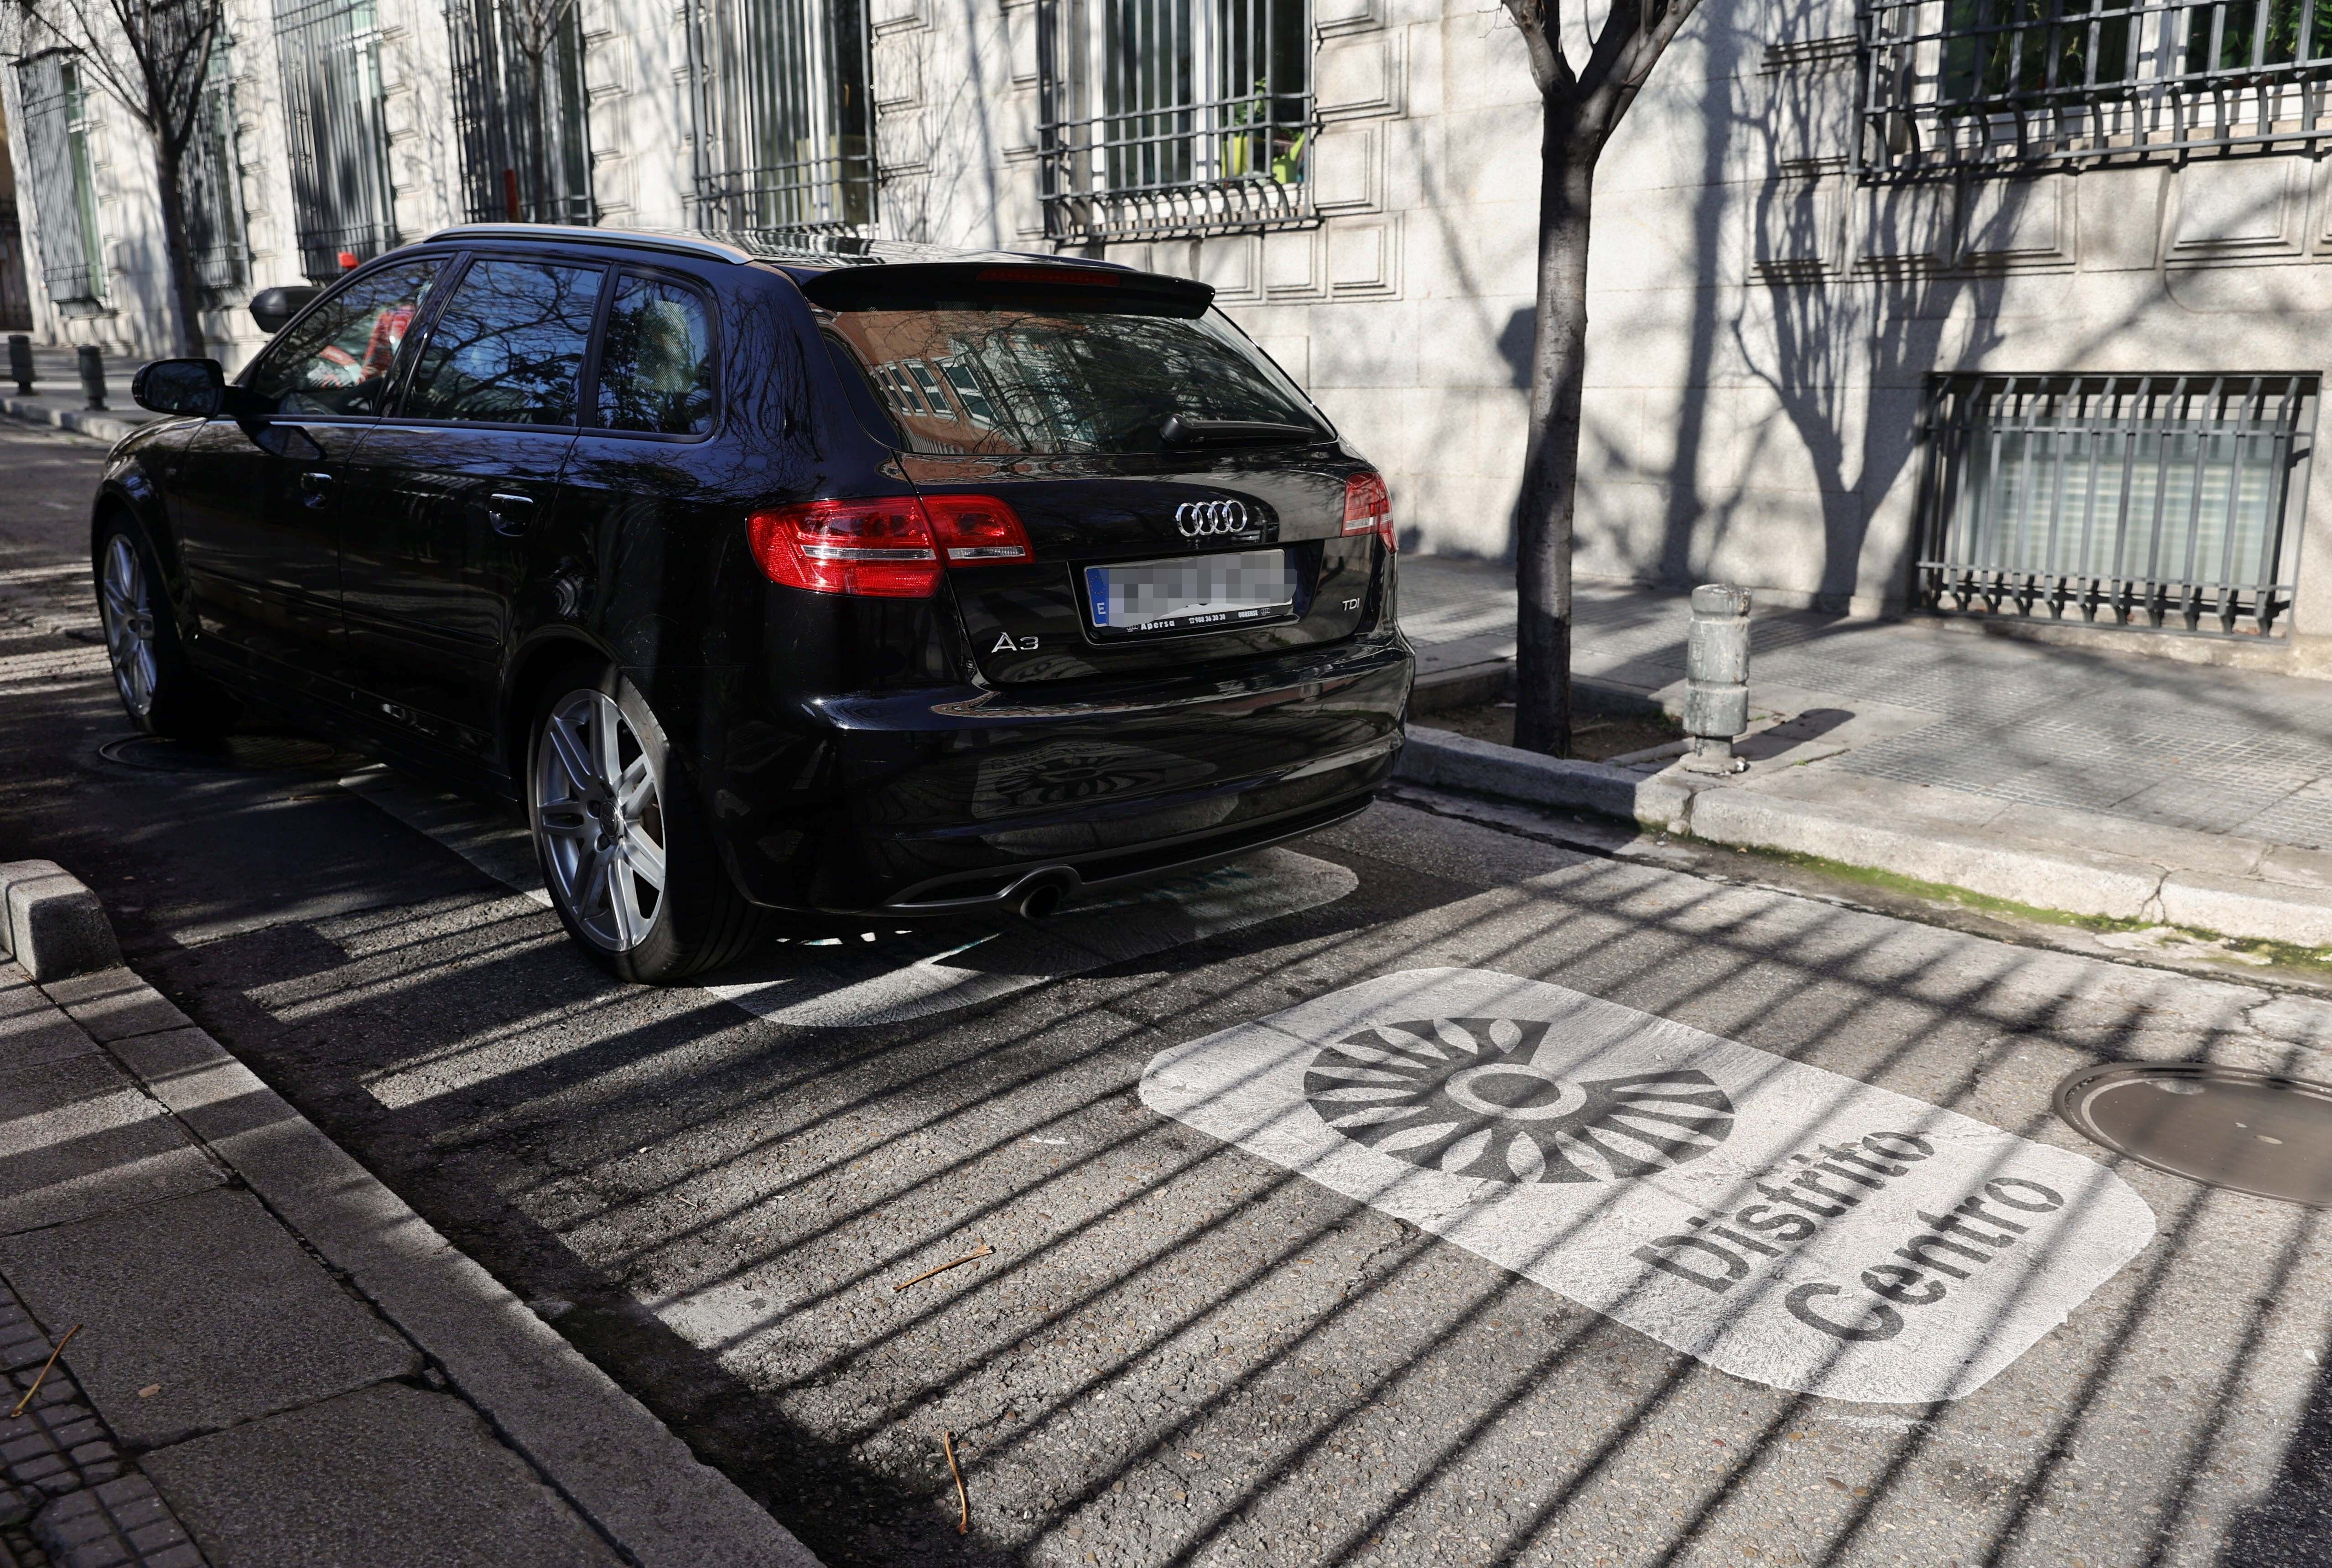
[1038,0,1315,240]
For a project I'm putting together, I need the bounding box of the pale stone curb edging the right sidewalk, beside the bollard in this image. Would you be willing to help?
[1395,726,2332,947]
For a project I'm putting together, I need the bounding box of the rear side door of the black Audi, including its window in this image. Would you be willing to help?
[340,254,606,756]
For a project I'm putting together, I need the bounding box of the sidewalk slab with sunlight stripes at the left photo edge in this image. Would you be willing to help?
[0,1054,224,1234]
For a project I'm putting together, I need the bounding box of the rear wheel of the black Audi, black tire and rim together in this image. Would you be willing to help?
[525,663,765,985]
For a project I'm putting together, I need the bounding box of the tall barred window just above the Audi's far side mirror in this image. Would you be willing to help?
[275,0,396,282]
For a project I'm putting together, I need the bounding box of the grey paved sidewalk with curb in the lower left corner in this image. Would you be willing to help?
[0,882,816,1568]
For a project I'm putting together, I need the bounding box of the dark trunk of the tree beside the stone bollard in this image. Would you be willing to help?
[1513,103,1595,756]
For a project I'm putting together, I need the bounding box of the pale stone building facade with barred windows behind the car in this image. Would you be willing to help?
[0,0,2332,675]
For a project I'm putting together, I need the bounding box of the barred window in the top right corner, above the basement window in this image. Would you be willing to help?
[1861,0,2332,173]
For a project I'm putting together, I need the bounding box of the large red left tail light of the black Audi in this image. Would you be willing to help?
[746,495,1033,600]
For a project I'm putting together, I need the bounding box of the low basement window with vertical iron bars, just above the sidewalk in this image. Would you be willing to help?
[1917,376,2316,637]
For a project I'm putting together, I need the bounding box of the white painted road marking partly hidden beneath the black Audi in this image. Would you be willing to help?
[340,768,1360,1027]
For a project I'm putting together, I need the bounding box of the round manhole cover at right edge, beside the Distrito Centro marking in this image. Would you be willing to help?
[2057,1062,2332,1209]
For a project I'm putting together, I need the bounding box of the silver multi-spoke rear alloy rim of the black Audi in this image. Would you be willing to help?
[534,691,665,952]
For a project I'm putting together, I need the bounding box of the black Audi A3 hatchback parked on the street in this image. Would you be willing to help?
[93,224,1411,980]
